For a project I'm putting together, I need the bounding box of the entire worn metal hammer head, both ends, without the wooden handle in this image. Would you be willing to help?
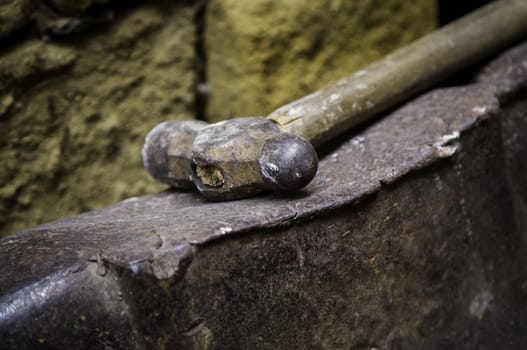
[143,117,318,200]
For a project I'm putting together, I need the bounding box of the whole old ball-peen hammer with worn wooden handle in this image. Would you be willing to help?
[142,0,527,201]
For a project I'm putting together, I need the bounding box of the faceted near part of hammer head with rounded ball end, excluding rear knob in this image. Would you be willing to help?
[191,117,318,200]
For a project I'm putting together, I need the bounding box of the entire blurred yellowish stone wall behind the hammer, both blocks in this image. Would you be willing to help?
[0,0,436,236]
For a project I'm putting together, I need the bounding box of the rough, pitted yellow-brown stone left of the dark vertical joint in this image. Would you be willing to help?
[0,1,196,233]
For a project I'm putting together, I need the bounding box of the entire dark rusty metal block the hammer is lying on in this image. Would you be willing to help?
[0,44,527,349]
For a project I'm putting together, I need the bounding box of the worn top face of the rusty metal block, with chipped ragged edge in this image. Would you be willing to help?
[0,44,527,294]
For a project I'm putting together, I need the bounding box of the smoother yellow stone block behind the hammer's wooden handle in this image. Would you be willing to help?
[205,0,436,121]
